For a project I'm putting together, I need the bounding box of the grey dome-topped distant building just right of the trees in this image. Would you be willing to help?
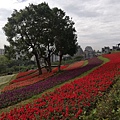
[84,46,95,59]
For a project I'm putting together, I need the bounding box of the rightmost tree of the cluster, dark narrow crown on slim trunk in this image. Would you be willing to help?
[53,8,78,71]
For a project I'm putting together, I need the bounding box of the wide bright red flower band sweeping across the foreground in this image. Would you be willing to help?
[0,53,120,120]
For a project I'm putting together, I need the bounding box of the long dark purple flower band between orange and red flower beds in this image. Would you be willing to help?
[0,58,102,108]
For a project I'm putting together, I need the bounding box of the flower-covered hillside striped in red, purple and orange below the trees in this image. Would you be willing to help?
[0,52,120,120]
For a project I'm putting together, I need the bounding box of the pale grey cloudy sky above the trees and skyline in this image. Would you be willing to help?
[0,0,120,50]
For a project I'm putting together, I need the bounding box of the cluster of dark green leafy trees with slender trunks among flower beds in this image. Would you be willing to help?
[3,2,77,74]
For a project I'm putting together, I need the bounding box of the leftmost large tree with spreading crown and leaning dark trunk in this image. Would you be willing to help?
[3,3,51,74]
